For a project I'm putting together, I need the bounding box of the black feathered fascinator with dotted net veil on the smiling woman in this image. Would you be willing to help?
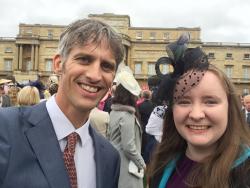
[155,34,209,104]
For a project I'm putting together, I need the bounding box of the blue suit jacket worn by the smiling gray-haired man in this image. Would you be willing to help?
[0,102,120,188]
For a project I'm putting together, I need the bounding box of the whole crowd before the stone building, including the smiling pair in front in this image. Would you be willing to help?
[0,19,250,188]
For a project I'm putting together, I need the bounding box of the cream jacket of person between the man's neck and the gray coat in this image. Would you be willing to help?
[89,107,109,138]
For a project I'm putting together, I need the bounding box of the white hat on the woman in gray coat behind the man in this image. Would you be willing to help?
[116,71,141,96]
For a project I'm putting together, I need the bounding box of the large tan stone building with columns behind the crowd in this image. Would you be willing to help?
[0,13,250,94]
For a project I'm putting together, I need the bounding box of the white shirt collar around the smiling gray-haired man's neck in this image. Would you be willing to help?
[46,95,91,145]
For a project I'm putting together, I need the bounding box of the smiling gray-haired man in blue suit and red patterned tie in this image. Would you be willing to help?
[0,19,124,188]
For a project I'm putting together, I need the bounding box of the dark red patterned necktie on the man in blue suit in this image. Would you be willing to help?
[63,132,78,188]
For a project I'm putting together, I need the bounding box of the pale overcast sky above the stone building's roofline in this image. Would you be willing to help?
[0,0,250,43]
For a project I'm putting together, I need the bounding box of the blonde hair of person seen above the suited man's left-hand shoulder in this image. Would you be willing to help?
[17,86,40,106]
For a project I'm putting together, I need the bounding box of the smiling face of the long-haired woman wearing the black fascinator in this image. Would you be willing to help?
[173,71,228,159]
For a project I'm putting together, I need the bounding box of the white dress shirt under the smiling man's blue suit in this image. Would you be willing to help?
[46,95,96,188]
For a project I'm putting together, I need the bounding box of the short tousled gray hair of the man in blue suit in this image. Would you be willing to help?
[58,19,124,67]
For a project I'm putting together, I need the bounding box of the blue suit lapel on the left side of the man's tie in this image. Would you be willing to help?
[26,103,70,188]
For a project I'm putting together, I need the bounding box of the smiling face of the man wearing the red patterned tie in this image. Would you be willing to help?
[54,42,116,116]
